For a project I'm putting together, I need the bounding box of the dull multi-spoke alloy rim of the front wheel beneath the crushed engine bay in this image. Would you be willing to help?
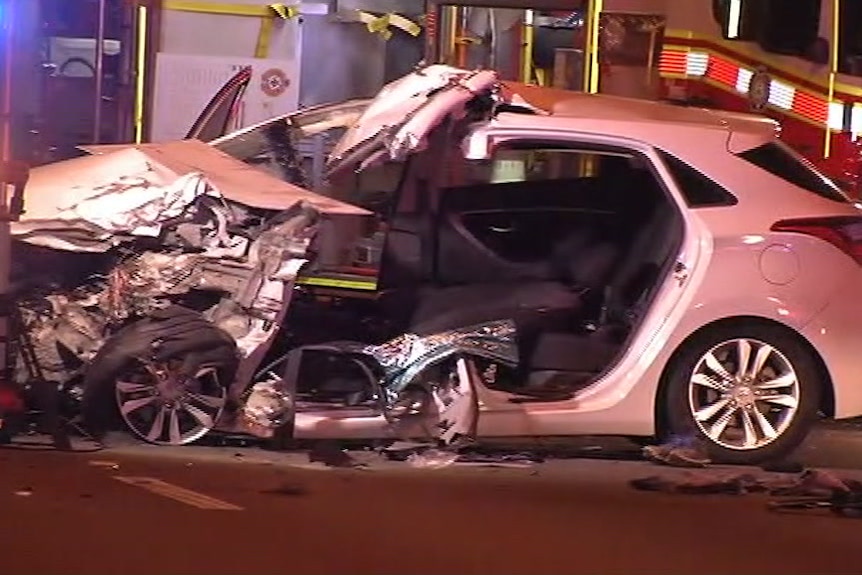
[115,358,227,445]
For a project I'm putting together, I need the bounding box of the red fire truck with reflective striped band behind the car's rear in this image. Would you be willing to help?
[660,0,862,194]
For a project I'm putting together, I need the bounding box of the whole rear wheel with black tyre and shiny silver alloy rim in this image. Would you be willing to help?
[663,322,825,464]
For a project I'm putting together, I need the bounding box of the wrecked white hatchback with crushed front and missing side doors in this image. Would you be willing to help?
[13,66,862,461]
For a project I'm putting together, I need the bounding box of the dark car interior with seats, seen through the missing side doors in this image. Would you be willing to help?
[374,149,682,396]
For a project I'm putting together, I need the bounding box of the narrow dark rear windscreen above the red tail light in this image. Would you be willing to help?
[738,142,850,203]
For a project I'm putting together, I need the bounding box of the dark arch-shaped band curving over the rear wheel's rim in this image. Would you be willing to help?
[653,315,835,436]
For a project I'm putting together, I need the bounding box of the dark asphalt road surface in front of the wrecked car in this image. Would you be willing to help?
[5,429,862,575]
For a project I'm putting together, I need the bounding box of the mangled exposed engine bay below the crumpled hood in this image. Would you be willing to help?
[14,179,328,440]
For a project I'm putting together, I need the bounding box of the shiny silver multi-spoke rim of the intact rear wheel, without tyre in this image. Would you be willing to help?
[688,338,800,451]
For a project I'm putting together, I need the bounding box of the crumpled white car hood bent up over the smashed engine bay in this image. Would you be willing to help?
[16,140,368,251]
